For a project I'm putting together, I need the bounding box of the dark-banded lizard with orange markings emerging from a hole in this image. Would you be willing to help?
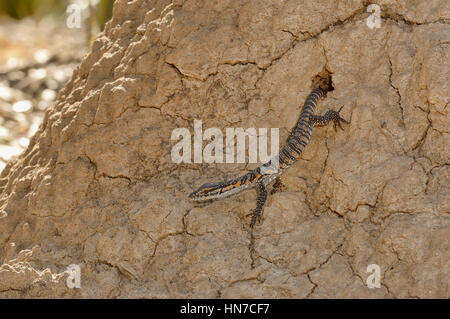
[189,86,349,228]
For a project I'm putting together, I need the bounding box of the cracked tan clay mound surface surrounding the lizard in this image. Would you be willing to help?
[0,0,450,298]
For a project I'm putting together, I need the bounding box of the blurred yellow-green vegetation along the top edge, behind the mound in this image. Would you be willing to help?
[0,0,114,30]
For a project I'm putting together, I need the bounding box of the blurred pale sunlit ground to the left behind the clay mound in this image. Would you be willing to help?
[0,18,87,171]
